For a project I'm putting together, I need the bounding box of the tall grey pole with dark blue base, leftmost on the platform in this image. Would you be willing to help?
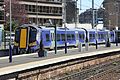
[9,0,12,63]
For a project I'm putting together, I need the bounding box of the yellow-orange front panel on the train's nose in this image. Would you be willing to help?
[20,29,27,48]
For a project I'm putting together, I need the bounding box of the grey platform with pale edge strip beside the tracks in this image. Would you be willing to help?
[0,44,120,76]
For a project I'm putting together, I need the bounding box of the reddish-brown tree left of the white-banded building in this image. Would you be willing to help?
[4,0,28,31]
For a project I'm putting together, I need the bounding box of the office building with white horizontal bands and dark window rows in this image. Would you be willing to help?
[20,0,62,25]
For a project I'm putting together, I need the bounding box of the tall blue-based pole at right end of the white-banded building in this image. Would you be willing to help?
[62,0,67,54]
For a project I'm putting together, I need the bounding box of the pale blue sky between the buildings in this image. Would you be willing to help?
[77,0,104,13]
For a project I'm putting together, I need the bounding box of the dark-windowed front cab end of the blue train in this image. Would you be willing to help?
[13,25,41,54]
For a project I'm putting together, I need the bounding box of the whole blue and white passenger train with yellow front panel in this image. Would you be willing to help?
[13,24,120,54]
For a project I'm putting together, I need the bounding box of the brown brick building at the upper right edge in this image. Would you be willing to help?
[103,0,120,30]
